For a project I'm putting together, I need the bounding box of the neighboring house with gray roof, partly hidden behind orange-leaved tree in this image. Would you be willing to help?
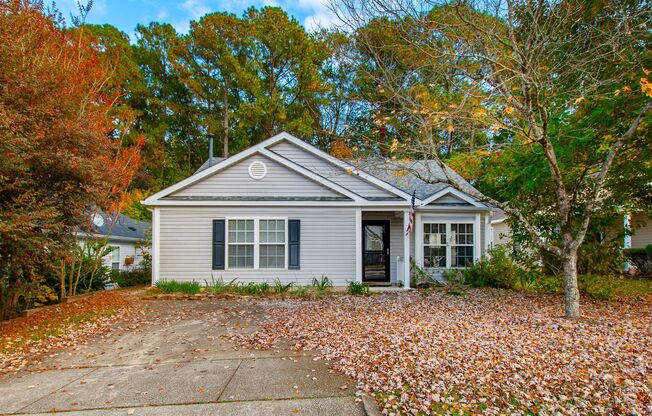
[77,211,151,271]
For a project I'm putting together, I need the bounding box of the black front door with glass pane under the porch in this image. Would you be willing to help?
[362,220,389,282]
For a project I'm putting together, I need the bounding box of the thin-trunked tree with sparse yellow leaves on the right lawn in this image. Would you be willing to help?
[339,0,652,318]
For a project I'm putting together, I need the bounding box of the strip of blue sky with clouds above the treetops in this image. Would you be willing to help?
[54,0,336,41]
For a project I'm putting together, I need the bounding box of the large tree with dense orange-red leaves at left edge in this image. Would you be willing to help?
[0,0,139,315]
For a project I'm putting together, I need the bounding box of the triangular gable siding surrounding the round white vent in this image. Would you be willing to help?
[172,155,343,197]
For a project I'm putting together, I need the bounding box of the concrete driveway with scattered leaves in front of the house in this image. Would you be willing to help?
[0,300,366,415]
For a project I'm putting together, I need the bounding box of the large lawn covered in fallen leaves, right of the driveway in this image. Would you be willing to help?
[232,290,652,414]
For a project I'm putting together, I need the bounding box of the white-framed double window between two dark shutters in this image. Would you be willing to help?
[226,218,287,269]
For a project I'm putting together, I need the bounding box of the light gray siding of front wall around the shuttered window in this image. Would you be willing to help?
[158,207,356,286]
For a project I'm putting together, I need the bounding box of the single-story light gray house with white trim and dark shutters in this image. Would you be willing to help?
[143,133,492,287]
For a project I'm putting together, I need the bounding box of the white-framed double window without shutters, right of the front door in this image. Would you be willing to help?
[423,222,475,269]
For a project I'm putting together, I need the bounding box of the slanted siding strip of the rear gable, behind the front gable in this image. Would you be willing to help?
[270,140,396,198]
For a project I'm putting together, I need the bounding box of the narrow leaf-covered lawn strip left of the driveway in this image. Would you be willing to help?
[0,290,136,374]
